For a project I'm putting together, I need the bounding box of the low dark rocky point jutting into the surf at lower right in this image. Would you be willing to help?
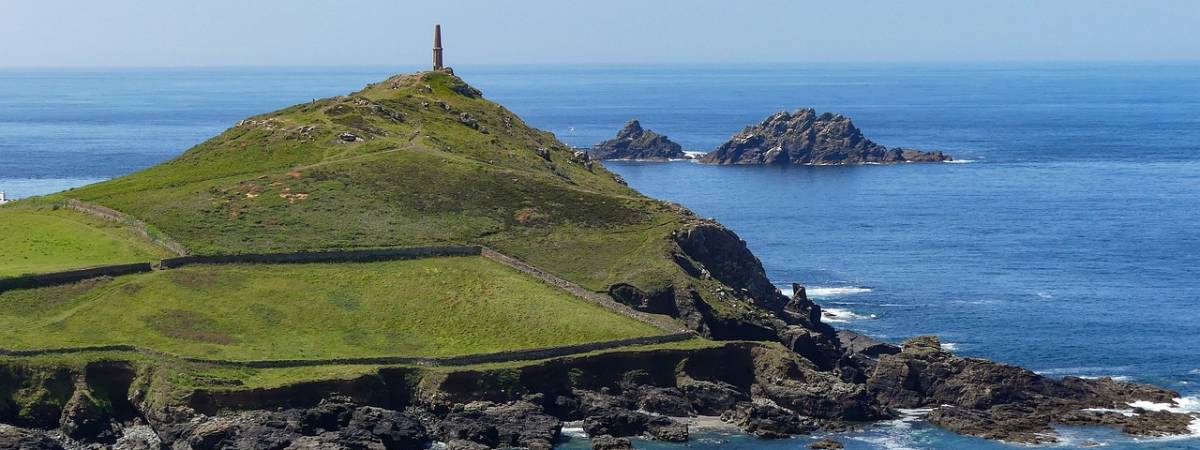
[866,336,1190,444]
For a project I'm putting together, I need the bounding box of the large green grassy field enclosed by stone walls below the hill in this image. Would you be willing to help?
[0,257,660,360]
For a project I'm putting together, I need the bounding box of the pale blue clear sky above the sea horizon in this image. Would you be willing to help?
[0,0,1200,67]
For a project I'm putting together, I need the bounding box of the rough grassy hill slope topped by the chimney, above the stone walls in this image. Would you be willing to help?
[58,72,682,290]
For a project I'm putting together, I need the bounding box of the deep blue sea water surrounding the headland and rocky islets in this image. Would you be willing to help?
[0,64,1200,449]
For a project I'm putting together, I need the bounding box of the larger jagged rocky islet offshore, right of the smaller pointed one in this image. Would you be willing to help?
[700,109,952,164]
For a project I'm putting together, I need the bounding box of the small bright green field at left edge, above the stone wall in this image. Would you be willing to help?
[0,208,170,277]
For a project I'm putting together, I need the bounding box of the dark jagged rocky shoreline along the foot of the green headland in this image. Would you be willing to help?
[0,321,1198,450]
